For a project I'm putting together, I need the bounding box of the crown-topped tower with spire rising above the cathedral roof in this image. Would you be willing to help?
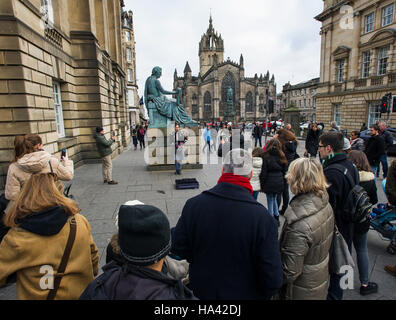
[198,16,224,76]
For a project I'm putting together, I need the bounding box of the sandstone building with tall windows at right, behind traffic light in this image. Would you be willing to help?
[315,0,396,133]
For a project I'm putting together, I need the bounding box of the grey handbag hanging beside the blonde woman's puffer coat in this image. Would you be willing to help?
[329,225,355,274]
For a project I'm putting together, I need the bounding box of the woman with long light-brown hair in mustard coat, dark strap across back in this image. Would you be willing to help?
[0,173,99,300]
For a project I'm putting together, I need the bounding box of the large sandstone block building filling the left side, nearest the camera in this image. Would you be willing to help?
[0,0,131,188]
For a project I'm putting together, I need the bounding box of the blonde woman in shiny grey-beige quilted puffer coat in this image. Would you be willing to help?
[280,158,334,300]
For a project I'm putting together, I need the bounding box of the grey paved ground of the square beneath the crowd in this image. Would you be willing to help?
[0,134,396,300]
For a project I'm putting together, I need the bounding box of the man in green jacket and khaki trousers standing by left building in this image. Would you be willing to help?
[94,127,118,184]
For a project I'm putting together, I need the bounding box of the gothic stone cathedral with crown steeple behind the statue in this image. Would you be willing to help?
[173,16,276,122]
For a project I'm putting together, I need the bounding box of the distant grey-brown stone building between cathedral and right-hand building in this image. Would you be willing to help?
[283,78,320,121]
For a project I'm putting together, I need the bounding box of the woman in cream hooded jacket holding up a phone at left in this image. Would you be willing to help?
[5,134,74,213]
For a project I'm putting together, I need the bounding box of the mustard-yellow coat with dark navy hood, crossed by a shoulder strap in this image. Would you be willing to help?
[0,206,99,300]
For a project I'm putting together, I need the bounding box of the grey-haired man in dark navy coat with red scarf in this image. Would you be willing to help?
[171,149,283,300]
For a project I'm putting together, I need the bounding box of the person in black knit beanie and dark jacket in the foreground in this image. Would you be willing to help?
[80,203,196,300]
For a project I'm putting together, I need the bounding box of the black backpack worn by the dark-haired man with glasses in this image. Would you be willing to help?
[331,164,372,223]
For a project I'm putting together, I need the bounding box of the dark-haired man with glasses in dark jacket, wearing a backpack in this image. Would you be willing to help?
[319,131,359,300]
